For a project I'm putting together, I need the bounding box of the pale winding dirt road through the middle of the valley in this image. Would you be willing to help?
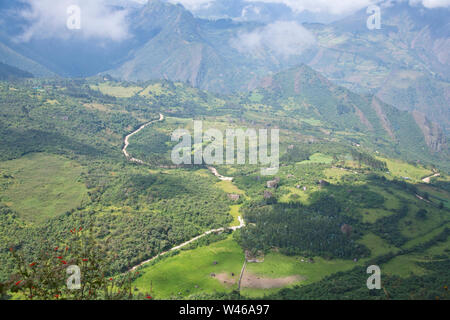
[122,113,245,271]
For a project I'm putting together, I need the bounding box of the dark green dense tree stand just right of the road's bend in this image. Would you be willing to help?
[238,198,370,259]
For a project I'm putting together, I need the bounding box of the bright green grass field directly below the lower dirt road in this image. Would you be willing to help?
[133,235,244,299]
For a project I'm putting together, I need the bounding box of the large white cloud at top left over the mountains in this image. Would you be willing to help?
[19,0,129,41]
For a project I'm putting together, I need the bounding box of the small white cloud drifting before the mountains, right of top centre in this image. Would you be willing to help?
[230,21,316,58]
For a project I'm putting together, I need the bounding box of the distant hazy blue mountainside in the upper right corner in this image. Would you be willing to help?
[308,2,450,128]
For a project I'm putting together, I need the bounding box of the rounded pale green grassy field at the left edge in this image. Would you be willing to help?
[0,153,87,222]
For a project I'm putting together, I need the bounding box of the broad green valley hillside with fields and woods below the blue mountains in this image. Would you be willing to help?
[0,77,449,299]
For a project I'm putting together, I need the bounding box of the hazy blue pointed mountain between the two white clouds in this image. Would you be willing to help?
[108,0,270,92]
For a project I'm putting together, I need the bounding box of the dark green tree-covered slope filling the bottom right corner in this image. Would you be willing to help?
[265,228,450,300]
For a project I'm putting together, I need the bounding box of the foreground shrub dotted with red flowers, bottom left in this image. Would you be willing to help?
[3,228,136,300]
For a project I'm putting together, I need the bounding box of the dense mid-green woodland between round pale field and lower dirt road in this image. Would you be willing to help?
[0,162,232,279]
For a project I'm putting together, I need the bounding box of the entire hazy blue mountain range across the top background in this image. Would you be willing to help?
[0,0,450,133]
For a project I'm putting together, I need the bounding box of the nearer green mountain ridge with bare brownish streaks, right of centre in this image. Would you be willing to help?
[250,65,448,165]
